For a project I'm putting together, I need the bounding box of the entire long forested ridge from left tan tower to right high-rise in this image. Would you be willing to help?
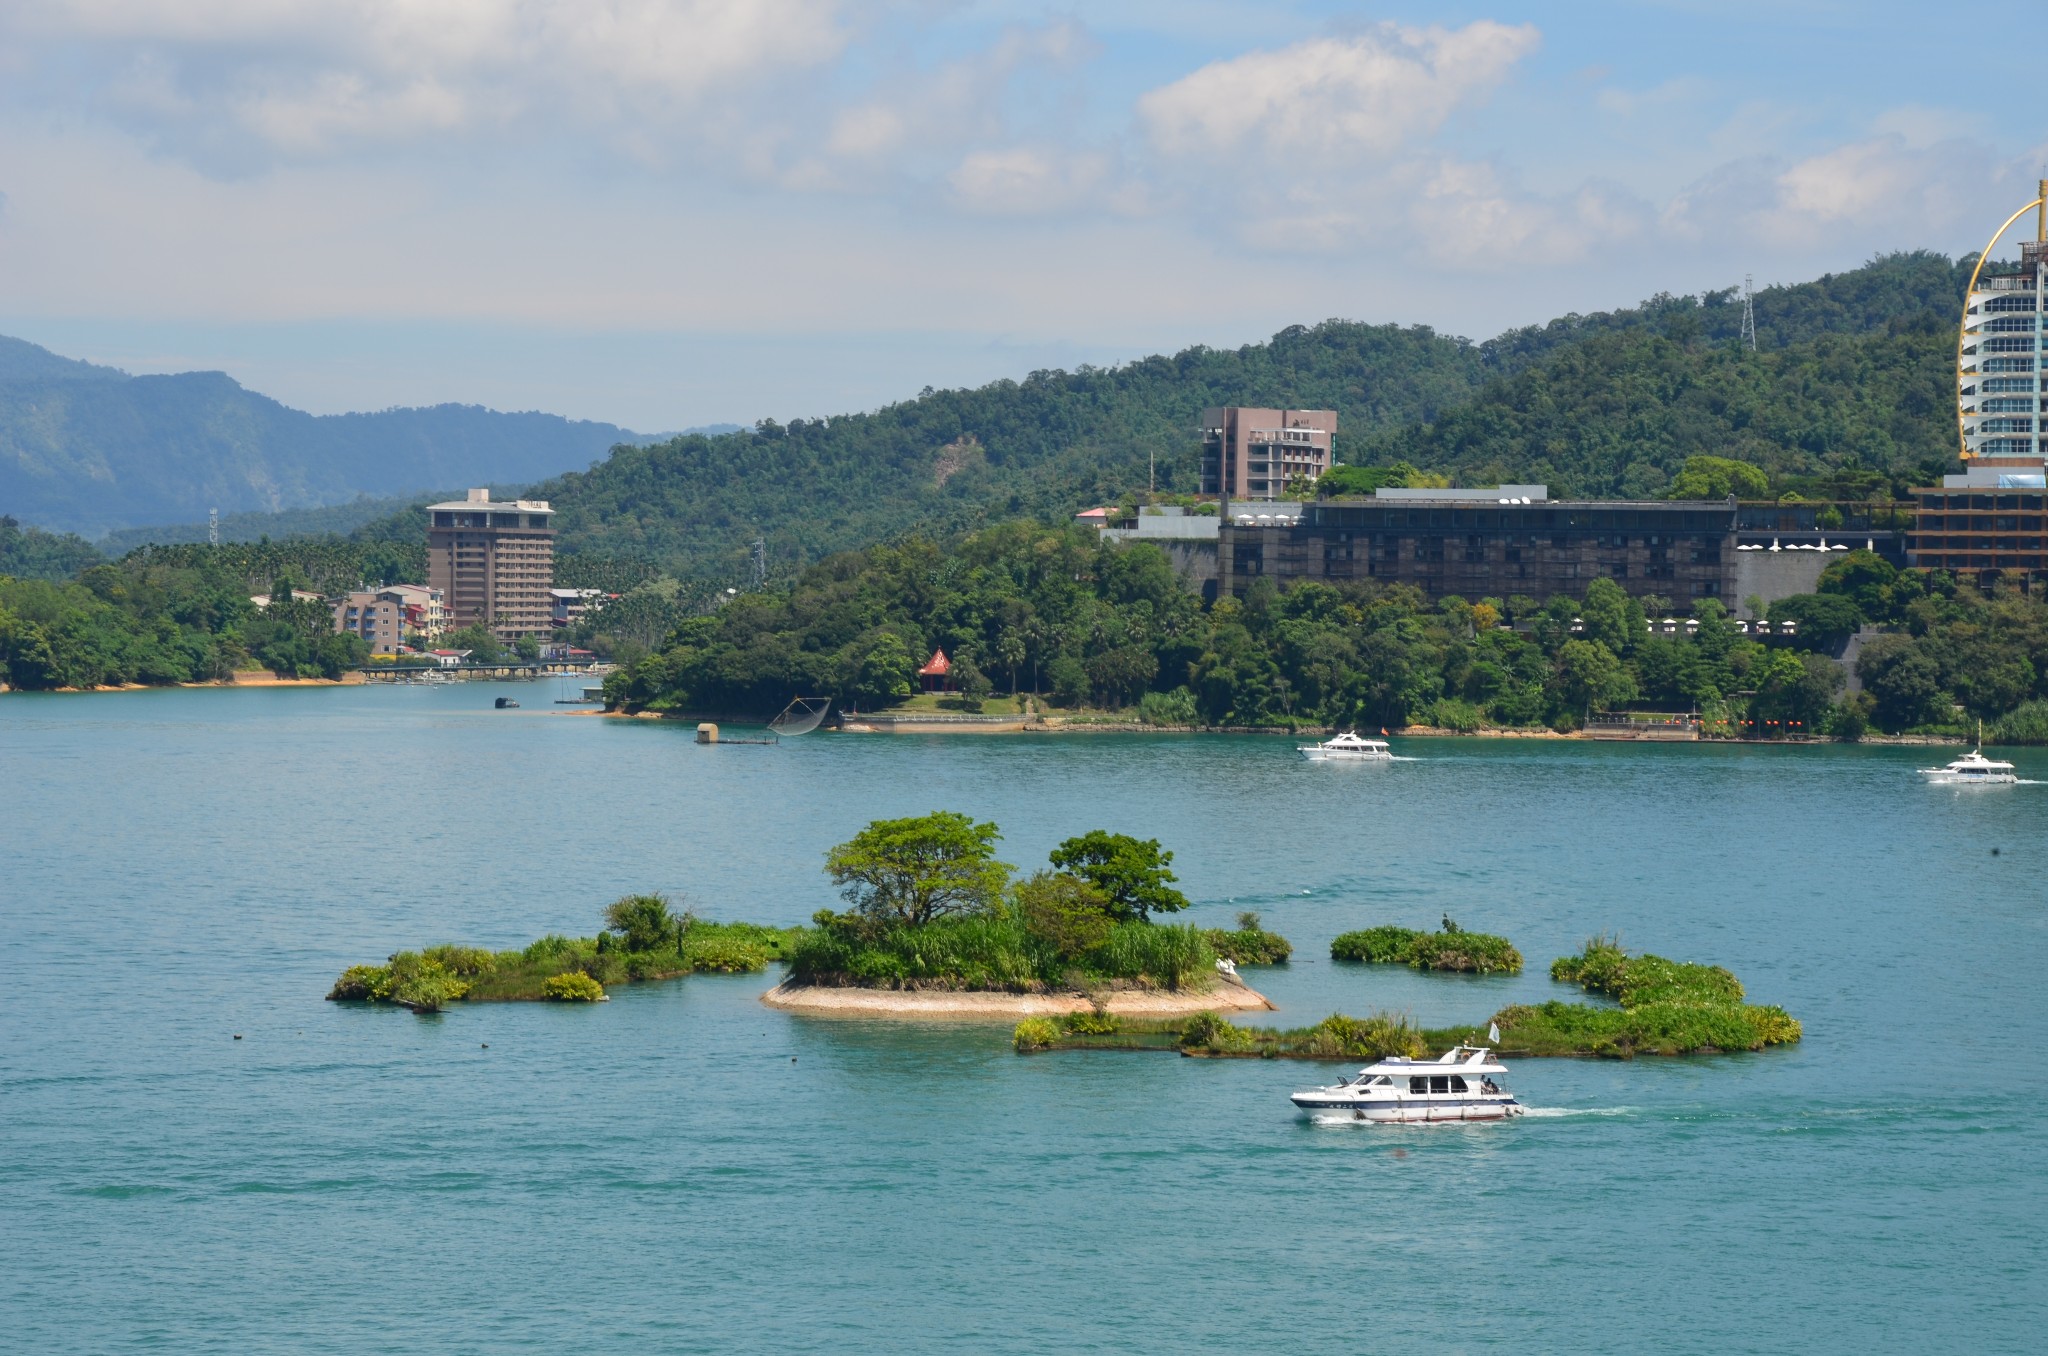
[532,252,1966,578]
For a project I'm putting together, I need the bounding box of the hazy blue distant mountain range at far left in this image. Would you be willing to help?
[0,338,659,537]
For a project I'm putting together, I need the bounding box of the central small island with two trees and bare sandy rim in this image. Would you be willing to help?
[762,811,1292,1018]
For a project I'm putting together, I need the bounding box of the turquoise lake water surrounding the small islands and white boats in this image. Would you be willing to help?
[0,686,2048,1352]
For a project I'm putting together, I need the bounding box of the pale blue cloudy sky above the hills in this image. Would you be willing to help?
[0,0,2048,430]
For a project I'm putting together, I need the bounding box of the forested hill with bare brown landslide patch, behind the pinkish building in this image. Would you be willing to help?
[532,322,1485,578]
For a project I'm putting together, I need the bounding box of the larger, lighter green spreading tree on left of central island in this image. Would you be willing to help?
[825,809,1010,926]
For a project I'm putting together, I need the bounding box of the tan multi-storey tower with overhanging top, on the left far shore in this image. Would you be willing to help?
[426,490,555,641]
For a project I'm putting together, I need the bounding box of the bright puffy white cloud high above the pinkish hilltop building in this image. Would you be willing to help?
[1139,20,1540,160]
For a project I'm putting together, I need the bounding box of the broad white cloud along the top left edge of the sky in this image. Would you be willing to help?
[12,0,852,160]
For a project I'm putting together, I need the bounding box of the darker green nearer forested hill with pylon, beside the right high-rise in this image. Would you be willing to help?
[1348,254,1968,498]
